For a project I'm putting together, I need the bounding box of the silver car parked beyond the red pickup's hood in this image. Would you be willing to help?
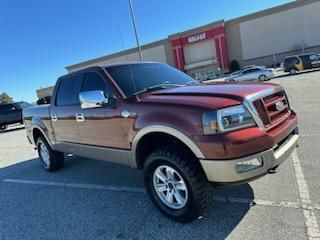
[225,67,274,82]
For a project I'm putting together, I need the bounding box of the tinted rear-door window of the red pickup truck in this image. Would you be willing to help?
[56,75,81,106]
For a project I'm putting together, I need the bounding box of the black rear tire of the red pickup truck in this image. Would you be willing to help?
[37,137,64,172]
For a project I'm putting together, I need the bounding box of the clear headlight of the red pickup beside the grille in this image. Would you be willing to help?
[202,105,256,135]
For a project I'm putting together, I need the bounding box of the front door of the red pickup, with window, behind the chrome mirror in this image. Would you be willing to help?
[79,70,126,149]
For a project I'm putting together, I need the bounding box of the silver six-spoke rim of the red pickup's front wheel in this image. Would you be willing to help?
[153,165,188,209]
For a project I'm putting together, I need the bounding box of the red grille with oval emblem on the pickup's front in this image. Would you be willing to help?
[253,91,291,129]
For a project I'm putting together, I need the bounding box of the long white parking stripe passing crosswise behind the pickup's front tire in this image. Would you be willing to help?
[3,179,320,210]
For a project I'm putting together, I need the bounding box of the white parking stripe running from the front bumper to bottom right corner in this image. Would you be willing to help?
[292,150,320,240]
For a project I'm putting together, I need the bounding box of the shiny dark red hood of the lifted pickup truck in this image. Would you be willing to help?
[140,83,280,109]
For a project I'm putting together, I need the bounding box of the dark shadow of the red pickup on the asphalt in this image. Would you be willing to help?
[0,157,254,240]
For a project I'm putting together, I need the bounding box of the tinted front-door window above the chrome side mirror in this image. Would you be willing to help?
[81,72,114,97]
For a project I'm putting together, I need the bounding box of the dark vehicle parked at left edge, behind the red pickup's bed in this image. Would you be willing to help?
[0,102,31,130]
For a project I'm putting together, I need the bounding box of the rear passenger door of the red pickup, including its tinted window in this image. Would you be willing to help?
[50,74,83,143]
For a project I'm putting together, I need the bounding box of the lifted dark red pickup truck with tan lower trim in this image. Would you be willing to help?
[23,63,298,222]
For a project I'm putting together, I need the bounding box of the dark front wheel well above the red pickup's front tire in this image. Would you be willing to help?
[136,132,196,169]
